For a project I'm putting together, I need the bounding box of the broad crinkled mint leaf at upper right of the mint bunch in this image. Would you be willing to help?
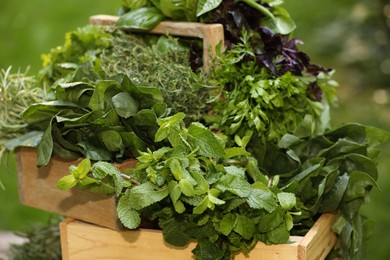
[187,122,225,158]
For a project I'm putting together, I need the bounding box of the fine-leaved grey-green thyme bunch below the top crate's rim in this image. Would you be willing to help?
[101,31,212,121]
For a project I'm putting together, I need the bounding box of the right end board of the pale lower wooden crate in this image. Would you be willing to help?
[298,213,337,260]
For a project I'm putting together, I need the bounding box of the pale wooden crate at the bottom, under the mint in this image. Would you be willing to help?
[60,214,336,260]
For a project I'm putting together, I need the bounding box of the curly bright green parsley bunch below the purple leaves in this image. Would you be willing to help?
[207,33,337,142]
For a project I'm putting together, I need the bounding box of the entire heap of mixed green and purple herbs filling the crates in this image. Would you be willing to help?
[1,0,390,260]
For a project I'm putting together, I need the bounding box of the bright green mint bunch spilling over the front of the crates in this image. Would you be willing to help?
[58,113,299,260]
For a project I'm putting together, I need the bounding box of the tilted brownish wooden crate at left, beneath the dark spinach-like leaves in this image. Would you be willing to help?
[15,148,136,230]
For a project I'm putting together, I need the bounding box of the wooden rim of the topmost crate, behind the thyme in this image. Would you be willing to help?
[89,14,224,72]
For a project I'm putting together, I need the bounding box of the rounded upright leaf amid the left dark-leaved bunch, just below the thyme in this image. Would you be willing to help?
[112,92,139,118]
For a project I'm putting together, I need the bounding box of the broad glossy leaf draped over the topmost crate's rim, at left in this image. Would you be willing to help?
[116,7,164,31]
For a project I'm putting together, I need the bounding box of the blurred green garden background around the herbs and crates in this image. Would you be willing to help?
[0,0,390,260]
